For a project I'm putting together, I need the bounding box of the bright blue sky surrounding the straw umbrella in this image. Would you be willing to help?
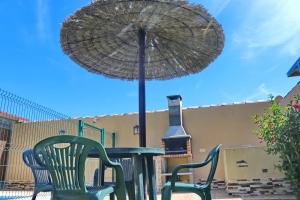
[0,0,300,116]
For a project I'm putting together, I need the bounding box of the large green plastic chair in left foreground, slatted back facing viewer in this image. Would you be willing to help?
[34,135,126,200]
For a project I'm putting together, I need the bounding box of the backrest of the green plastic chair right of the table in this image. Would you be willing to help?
[204,144,222,185]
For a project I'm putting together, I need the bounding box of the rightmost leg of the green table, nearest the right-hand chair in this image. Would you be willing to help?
[146,156,157,200]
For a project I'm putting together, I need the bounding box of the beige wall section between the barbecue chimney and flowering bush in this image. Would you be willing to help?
[184,102,269,179]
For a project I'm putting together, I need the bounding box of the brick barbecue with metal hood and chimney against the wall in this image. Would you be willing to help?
[156,95,193,188]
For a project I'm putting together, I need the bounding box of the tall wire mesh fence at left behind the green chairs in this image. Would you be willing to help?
[0,89,78,199]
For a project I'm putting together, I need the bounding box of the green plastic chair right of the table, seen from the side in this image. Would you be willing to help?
[161,144,222,200]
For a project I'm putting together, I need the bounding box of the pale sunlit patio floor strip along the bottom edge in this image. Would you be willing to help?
[0,190,296,200]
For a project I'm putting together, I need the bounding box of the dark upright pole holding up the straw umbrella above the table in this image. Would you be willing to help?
[138,28,146,147]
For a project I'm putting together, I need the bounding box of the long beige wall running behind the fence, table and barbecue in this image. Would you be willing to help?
[9,102,270,184]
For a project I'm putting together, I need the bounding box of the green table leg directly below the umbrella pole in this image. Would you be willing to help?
[133,156,144,200]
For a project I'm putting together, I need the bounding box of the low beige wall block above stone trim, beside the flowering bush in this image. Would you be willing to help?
[224,147,284,182]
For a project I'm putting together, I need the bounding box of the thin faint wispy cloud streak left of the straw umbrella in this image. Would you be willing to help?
[36,0,50,40]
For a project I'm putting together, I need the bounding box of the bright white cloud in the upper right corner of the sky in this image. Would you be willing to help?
[233,0,300,59]
